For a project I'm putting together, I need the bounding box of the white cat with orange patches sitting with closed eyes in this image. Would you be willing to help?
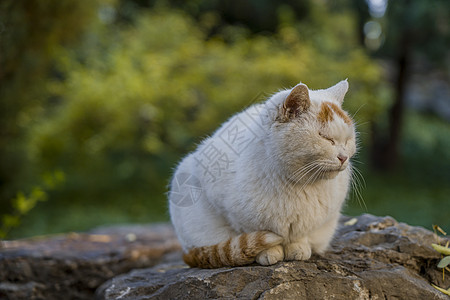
[169,80,356,268]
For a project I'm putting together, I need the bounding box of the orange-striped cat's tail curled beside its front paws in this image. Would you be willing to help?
[183,231,283,269]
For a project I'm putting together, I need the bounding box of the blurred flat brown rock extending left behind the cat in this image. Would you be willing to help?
[0,224,180,299]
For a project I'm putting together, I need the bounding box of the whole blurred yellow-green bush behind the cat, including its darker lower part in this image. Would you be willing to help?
[14,7,387,234]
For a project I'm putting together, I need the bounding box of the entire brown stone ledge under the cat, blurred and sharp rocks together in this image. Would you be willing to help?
[0,214,450,299]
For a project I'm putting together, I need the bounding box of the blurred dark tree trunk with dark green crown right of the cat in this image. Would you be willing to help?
[362,0,450,170]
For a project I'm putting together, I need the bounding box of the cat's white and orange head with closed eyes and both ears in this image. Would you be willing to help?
[269,80,356,182]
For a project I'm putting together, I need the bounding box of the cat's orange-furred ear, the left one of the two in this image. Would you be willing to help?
[282,83,311,119]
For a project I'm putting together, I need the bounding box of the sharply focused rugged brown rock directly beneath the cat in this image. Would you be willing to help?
[96,214,450,299]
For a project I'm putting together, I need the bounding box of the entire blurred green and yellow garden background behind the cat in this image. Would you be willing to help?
[0,0,450,238]
